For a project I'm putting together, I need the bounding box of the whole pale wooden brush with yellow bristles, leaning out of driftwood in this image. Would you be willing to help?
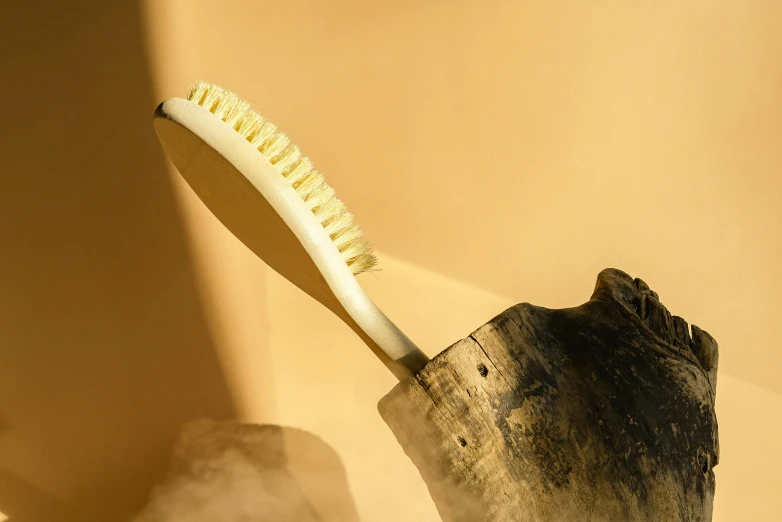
[154,82,429,380]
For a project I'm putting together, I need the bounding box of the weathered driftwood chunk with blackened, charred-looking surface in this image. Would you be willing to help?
[378,269,719,522]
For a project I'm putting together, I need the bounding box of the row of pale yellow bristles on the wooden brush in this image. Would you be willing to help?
[187,81,377,275]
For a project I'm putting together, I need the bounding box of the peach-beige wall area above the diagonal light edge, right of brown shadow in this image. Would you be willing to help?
[148,0,782,392]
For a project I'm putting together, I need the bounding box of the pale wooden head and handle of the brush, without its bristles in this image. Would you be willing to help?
[154,98,429,380]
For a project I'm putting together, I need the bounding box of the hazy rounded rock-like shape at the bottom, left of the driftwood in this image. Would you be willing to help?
[133,420,358,522]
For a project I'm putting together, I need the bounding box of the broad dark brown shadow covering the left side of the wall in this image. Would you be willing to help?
[0,0,247,522]
